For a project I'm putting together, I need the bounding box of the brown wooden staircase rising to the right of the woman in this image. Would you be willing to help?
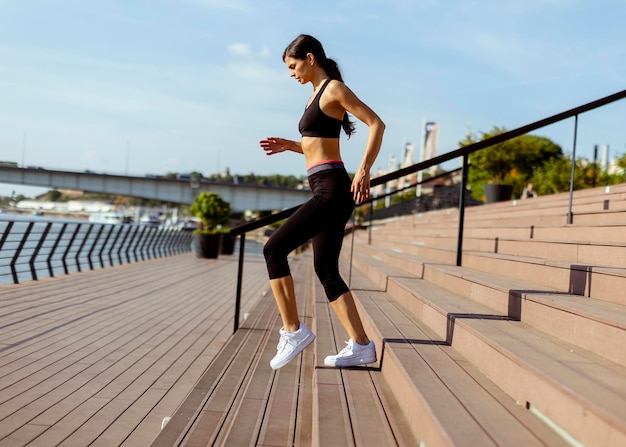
[342,184,626,447]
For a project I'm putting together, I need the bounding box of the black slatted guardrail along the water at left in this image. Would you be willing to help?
[0,220,192,284]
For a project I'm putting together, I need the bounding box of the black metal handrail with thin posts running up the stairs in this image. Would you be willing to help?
[230,90,626,332]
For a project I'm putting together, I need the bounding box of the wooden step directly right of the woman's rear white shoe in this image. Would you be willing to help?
[338,260,567,446]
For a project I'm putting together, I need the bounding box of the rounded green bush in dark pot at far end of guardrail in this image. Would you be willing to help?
[189,192,230,258]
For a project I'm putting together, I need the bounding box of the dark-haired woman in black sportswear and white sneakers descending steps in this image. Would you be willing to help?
[260,34,385,369]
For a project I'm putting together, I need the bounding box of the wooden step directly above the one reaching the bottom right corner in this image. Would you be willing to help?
[346,249,626,366]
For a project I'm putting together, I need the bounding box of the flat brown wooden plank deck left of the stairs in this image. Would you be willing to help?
[0,254,273,447]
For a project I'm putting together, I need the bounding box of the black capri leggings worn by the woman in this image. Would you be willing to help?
[263,162,354,302]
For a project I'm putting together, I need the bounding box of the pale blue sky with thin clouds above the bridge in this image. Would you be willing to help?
[0,0,626,196]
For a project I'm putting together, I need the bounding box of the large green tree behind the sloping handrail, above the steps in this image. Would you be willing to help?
[459,126,563,200]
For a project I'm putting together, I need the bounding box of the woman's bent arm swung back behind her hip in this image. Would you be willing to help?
[329,82,385,203]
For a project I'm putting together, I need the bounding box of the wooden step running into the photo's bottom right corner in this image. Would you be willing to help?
[344,259,626,446]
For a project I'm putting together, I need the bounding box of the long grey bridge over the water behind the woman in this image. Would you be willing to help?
[0,166,311,212]
